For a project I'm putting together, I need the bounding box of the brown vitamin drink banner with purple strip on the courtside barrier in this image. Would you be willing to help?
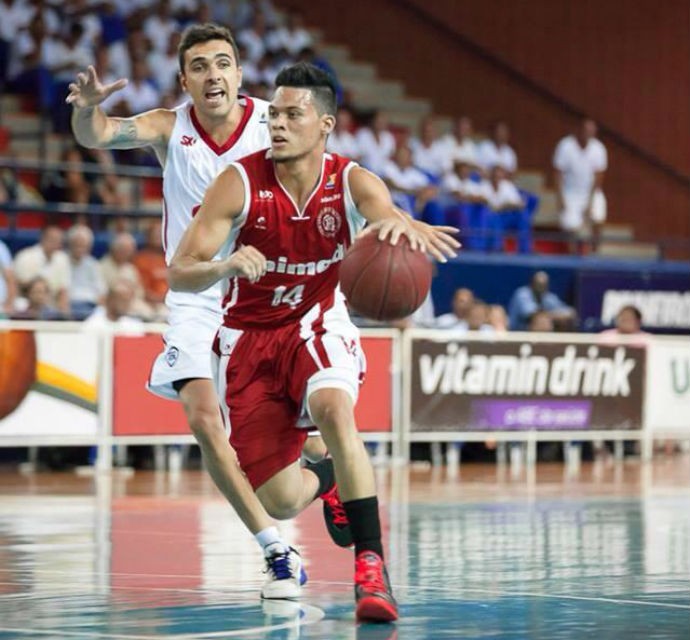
[410,339,645,432]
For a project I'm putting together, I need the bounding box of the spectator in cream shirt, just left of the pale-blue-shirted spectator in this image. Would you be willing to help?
[14,225,70,315]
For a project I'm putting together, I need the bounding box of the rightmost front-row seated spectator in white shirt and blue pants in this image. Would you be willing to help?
[483,165,532,253]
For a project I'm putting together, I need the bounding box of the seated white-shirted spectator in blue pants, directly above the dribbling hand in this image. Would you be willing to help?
[379,145,445,224]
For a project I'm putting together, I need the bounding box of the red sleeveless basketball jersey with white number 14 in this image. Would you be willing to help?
[223,150,365,329]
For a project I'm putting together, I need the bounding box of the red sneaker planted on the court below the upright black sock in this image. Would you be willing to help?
[355,551,398,622]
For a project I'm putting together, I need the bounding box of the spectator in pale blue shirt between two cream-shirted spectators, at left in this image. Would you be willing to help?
[67,224,105,320]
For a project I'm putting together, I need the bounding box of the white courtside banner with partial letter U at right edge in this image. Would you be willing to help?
[646,338,690,431]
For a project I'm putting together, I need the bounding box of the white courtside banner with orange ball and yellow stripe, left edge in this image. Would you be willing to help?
[0,330,99,439]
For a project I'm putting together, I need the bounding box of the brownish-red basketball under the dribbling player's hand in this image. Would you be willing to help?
[340,233,431,320]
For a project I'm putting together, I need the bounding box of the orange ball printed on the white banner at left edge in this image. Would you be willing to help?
[0,331,36,420]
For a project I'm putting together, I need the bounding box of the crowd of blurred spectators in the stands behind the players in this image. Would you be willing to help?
[0,0,606,332]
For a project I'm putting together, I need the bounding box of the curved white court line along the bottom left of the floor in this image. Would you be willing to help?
[0,604,326,640]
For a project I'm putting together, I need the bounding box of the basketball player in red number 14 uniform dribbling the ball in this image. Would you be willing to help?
[169,63,457,621]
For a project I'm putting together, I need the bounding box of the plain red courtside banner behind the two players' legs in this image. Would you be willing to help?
[113,335,393,436]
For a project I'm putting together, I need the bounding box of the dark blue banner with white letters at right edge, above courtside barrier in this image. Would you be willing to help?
[577,271,690,332]
